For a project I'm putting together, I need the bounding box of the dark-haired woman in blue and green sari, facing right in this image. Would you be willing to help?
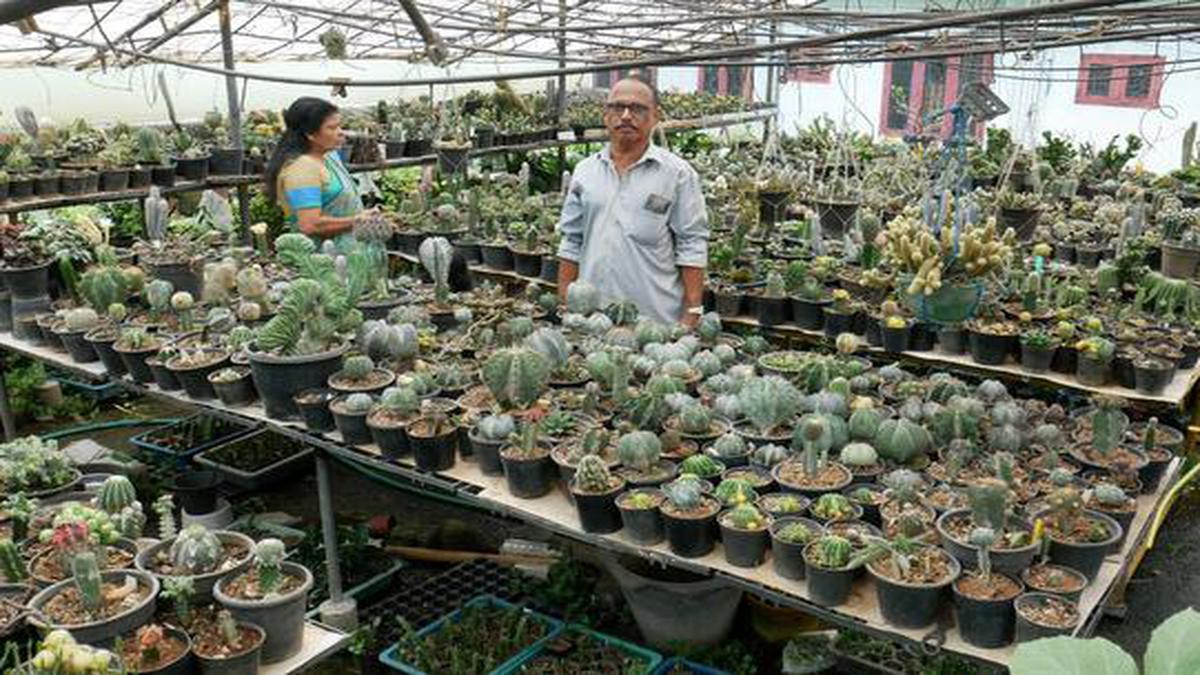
[264,96,362,239]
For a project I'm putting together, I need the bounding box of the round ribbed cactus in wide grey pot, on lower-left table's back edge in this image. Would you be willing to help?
[133,521,254,604]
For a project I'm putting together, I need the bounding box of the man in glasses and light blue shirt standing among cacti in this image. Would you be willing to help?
[558,78,708,328]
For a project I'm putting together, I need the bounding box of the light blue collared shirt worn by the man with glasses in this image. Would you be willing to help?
[558,144,708,323]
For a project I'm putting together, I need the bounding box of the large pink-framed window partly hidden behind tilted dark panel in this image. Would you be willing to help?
[880,54,992,138]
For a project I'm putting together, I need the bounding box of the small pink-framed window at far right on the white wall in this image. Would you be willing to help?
[1075,54,1166,108]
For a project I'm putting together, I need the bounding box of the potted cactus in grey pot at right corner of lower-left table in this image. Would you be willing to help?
[212,538,312,664]
